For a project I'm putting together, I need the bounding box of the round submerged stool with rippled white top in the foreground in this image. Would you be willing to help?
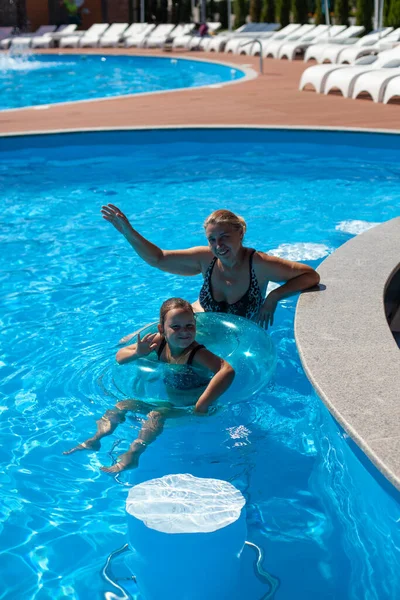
[126,474,247,600]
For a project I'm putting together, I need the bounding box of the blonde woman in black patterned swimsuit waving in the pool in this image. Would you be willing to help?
[101,204,319,329]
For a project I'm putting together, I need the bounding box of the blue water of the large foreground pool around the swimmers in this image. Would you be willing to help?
[0,130,400,600]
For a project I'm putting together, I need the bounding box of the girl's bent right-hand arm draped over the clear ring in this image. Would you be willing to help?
[193,348,235,413]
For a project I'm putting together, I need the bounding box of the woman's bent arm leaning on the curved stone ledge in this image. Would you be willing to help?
[257,252,320,328]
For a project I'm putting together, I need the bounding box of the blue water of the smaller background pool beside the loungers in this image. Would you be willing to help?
[0,54,244,110]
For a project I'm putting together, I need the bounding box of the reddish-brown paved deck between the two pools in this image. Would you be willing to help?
[0,48,400,133]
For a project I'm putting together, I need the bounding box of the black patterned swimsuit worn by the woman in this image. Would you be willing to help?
[199,250,264,320]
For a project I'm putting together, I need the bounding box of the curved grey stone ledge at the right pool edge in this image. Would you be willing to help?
[295,217,400,490]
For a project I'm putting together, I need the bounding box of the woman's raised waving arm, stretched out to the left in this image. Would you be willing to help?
[101,204,212,275]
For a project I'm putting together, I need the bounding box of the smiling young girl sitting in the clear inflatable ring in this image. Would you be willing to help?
[64,298,235,473]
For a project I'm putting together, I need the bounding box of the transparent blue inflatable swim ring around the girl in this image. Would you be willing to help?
[112,312,276,403]
